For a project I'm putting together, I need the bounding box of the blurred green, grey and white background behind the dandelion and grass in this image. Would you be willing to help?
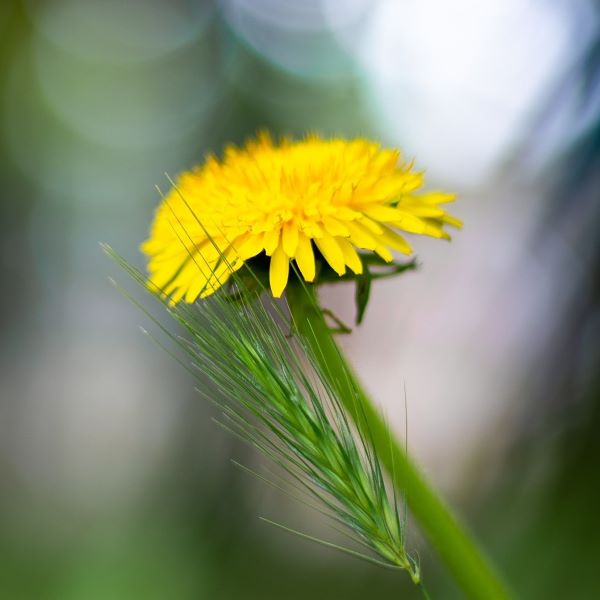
[0,0,600,600]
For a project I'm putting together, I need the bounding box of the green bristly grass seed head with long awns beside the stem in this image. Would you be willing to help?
[104,246,425,593]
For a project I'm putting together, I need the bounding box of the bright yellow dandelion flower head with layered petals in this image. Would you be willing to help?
[142,133,461,303]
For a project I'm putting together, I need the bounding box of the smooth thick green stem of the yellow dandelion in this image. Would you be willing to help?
[286,282,511,600]
